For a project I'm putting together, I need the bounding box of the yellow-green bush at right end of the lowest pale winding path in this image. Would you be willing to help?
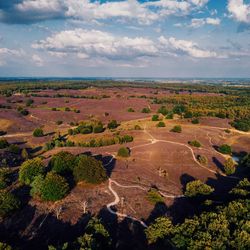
[184,180,214,197]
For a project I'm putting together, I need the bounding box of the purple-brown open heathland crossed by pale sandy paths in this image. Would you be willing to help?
[0,83,250,249]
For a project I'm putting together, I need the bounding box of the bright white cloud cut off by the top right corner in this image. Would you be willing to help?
[227,0,250,23]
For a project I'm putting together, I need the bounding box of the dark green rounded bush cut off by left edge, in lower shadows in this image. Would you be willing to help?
[0,190,20,218]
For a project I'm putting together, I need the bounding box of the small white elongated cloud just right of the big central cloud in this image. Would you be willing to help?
[159,36,218,58]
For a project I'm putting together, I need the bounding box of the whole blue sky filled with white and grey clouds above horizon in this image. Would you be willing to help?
[0,0,250,77]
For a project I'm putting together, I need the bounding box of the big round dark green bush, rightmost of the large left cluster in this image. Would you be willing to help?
[73,155,107,183]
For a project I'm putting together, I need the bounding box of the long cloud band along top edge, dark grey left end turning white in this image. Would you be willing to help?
[0,0,208,24]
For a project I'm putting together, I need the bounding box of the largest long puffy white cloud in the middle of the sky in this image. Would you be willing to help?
[32,29,158,60]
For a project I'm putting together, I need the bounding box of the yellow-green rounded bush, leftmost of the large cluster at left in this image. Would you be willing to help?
[19,158,45,185]
